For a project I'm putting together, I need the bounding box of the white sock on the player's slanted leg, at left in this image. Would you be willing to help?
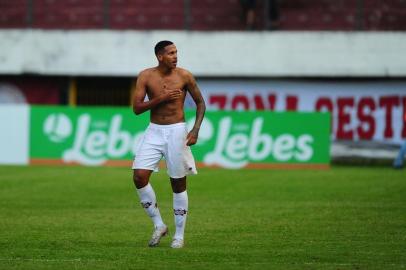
[137,183,165,227]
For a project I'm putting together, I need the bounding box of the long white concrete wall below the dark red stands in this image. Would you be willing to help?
[0,30,406,77]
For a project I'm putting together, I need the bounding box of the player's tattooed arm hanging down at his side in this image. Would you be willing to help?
[186,73,206,146]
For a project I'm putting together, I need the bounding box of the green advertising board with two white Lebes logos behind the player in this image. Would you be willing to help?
[35,107,329,168]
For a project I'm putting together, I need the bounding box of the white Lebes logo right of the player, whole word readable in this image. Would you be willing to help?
[188,116,314,169]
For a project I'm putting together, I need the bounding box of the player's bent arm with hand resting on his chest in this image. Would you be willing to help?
[133,71,182,115]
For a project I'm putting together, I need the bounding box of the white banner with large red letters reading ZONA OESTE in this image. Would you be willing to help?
[192,80,406,143]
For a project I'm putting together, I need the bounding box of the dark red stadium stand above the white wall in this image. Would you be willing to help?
[0,0,406,31]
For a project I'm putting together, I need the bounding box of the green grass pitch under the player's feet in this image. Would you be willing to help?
[0,166,406,270]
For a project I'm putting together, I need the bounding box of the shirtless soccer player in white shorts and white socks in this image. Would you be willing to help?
[132,41,206,248]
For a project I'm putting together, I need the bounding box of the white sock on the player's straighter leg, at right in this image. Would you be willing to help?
[173,190,188,239]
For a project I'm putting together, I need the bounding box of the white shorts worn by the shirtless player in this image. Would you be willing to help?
[132,123,197,178]
